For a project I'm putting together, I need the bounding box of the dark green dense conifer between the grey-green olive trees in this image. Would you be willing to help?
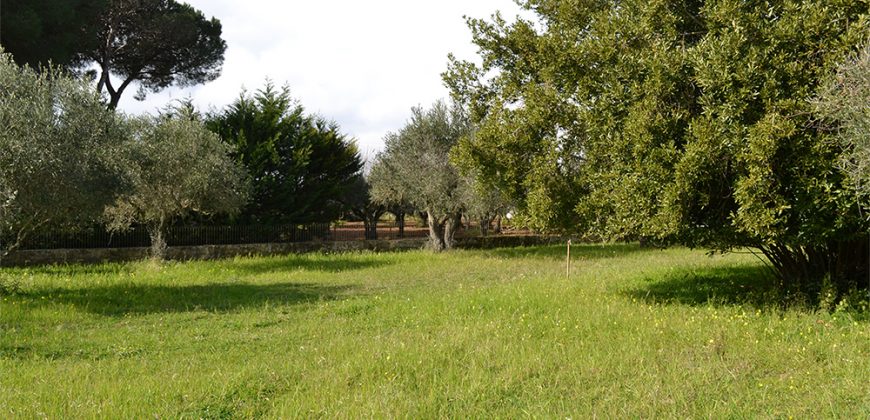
[208,83,362,224]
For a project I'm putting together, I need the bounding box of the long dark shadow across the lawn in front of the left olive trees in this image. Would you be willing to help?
[21,283,352,316]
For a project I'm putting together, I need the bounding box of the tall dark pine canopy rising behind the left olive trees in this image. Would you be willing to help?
[0,0,227,108]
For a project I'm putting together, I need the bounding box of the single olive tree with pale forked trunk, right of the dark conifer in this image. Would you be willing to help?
[373,102,471,251]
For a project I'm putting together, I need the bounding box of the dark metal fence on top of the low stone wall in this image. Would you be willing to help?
[11,222,428,249]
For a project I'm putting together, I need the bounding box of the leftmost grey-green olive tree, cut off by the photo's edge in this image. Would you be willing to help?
[0,54,125,254]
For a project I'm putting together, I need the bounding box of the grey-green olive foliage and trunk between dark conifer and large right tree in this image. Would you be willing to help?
[367,101,511,251]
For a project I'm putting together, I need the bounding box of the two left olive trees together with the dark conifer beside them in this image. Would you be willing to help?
[0,49,390,257]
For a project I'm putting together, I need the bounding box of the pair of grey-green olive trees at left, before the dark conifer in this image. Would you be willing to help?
[0,54,249,257]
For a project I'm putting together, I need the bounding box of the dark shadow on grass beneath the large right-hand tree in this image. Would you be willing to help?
[623,265,778,308]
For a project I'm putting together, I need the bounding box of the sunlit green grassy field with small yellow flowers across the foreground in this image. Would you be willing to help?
[0,245,870,418]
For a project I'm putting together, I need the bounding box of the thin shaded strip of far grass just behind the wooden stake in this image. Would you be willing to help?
[489,243,655,259]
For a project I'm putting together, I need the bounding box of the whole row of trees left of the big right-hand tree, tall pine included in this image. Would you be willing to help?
[0,0,506,257]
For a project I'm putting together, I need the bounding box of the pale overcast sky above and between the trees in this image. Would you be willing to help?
[120,0,519,157]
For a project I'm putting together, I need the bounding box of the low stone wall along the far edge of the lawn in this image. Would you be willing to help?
[0,236,559,267]
